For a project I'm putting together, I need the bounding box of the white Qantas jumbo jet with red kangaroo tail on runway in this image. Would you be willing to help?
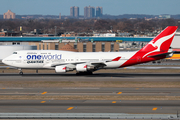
[2,26,178,75]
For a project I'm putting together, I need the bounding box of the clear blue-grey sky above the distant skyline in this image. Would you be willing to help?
[0,0,180,15]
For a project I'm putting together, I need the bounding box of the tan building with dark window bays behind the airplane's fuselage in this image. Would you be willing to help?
[29,41,119,52]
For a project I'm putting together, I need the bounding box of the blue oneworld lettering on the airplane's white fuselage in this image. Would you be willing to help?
[26,54,62,60]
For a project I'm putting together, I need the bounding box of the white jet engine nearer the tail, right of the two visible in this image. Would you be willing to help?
[76,64,94,72]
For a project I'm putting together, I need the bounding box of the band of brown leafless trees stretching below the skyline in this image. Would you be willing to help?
[0,19,180,35]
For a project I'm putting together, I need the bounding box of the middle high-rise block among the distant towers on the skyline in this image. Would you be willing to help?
[84,6,95,18]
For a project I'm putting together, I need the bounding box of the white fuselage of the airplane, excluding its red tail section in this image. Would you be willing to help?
[3,50,136,69]
